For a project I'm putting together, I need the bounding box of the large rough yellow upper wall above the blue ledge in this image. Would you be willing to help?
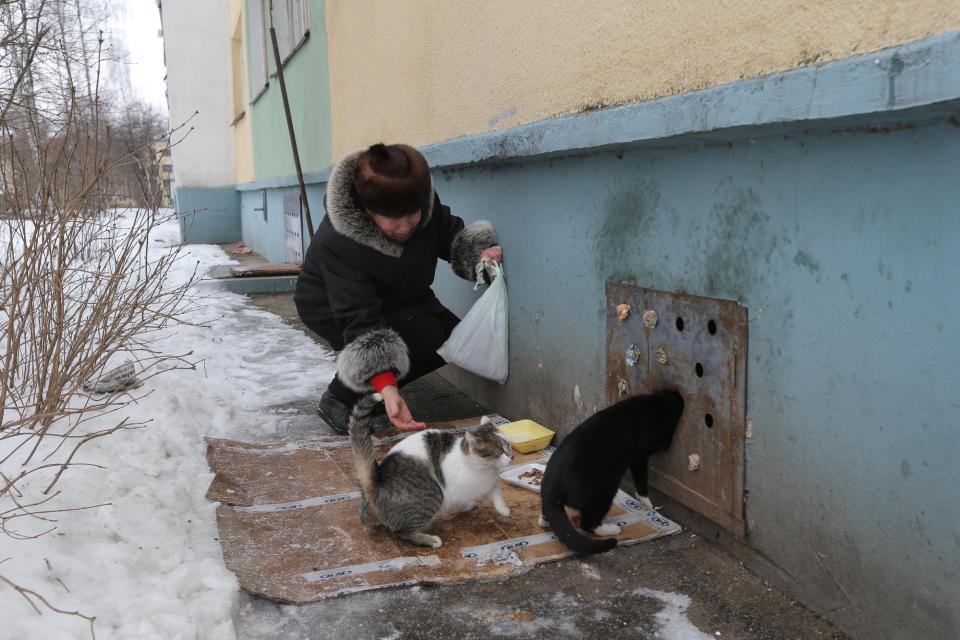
[326,0,960,159]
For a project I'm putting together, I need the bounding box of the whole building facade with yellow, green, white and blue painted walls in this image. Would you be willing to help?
[163,0,960,639]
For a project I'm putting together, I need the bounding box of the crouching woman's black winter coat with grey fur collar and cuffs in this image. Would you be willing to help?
[294,153,496,391]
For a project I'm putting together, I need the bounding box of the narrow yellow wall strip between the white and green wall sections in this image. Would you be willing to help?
[229,0,255,184]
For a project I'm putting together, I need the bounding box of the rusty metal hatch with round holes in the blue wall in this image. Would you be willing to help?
[606,282,747,537]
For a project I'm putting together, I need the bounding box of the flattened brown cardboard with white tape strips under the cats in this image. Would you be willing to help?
[207,417,680,603]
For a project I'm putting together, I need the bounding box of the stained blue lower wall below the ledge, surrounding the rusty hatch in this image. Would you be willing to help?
[436,110,960,640]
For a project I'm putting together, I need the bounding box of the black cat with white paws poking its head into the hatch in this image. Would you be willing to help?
[540,391,683,553]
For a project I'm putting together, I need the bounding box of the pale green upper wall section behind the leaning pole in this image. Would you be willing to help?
[248,0,331,180]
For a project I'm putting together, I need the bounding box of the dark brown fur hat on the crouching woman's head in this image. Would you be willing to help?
[353,143,433,218]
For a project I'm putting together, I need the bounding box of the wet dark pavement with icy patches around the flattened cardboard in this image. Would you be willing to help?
[235,294,847,640]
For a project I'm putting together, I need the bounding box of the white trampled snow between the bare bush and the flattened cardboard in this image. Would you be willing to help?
[0,215,334,640]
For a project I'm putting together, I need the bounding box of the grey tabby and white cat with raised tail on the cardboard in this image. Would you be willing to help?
[350,396,513,547]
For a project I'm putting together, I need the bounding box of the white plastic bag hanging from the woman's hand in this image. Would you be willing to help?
[437,260,509,384]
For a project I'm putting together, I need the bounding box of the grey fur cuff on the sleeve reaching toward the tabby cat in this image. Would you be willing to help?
[337,328,410,393]
